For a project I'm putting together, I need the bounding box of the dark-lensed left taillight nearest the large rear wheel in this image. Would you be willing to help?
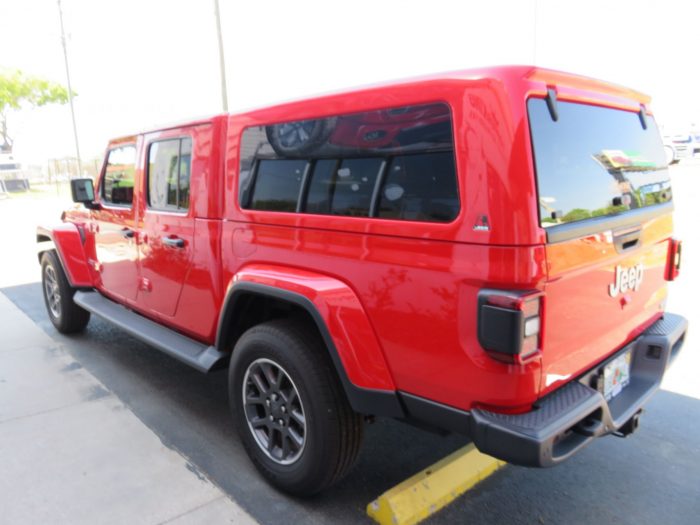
[478,289,544,364]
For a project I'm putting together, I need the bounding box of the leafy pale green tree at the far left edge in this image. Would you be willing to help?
[0,69,68,153]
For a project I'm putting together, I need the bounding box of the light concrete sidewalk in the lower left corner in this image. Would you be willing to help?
[0,292,255,525]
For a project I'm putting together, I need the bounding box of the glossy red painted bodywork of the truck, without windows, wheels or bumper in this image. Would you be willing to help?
[45,66,671,411]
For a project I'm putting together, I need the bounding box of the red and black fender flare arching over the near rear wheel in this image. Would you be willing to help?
[216,265,405,417]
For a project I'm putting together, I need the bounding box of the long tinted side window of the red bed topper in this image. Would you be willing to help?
[239,103,459,222]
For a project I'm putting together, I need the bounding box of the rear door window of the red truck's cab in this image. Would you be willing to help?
[147,137,192,211]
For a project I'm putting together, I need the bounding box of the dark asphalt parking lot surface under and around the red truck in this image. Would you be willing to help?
[0,161,700,524]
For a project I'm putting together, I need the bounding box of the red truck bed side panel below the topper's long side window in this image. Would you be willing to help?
[223,227,545,408]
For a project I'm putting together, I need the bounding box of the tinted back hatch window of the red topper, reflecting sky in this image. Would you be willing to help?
[528,99,671,227]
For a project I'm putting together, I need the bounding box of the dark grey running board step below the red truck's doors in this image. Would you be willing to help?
[73,291,227,372]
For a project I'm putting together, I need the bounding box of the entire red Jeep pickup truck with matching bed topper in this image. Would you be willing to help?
[37,66,687,494]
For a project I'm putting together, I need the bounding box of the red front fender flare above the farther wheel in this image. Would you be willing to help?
[36,222,93,288]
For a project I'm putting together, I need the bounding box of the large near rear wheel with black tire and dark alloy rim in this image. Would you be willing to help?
[228,320,363,496]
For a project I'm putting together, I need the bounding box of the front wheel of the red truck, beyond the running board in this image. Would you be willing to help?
[41,251,90,334]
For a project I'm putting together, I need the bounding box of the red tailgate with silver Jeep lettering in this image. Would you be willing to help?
[543,215,673,393]
